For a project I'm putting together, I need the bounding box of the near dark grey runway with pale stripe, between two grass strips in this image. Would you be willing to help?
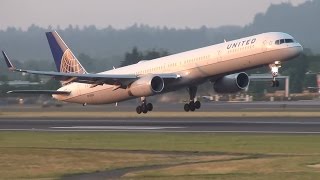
[0,117,320,134]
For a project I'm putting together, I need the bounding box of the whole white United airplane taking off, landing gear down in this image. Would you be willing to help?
[2,31,303,114]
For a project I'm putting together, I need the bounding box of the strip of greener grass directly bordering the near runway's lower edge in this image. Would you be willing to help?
[0,132,320,154]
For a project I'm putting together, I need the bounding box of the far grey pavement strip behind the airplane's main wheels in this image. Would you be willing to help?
[4,101,320,112]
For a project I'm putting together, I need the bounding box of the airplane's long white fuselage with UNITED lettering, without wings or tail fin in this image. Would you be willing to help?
[53,32,302,104]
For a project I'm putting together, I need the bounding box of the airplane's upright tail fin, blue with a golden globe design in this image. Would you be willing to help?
[46,31,87,74]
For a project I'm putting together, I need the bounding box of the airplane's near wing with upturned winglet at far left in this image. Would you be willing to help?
[2,51,180,85]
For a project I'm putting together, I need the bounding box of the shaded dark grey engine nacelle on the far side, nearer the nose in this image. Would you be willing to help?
[213,72,250,94]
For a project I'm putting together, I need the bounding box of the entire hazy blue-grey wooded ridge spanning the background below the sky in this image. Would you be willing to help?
[0,1,320,61]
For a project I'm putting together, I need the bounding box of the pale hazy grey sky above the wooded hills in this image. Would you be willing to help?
[0,0,308,30]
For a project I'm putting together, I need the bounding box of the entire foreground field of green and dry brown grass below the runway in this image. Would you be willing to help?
[0,132,320,179]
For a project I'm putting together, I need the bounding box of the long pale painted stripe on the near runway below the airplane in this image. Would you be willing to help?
[50,126,185,130]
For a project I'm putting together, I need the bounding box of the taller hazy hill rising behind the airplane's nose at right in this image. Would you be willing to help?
[242,0,320,54]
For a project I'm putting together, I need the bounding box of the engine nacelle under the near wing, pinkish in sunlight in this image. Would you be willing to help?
[127,75,164,97]
